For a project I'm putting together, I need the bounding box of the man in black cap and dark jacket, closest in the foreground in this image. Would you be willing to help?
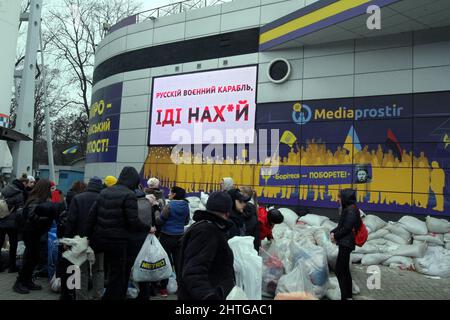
[177,192,235,300]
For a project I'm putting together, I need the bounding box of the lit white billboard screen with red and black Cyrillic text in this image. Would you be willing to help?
[149,66,257,145]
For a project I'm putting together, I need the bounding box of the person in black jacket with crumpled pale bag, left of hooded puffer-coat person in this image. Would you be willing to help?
[60,177,104,300]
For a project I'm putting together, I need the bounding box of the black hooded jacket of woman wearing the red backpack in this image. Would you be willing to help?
[331,189,361,250]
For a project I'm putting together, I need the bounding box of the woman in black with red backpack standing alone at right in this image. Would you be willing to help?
[331,189,362,300]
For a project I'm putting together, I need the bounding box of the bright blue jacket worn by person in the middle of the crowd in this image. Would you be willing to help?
[157,200,190,235]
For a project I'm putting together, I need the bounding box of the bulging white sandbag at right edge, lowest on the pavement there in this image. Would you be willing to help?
[414,247,450,278]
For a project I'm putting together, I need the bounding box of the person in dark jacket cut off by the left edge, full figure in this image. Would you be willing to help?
[0,177,28,273]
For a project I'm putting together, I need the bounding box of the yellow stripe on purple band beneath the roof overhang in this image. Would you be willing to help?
[259,0,371,44]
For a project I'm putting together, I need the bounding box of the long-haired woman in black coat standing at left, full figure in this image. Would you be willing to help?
[13,179,65,294]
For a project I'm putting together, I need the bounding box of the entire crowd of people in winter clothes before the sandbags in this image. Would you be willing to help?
[0,167,360,300]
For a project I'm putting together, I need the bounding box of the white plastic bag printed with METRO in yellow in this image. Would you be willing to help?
[133,234,172,282]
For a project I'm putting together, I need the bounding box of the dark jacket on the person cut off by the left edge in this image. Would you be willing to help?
[0,179,28,229]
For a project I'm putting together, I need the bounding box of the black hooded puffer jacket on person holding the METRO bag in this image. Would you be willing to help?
[84,167,149,251]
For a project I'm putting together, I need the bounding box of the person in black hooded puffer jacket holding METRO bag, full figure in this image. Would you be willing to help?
[86,167,150,300]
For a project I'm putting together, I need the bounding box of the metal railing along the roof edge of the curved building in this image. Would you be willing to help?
[136,0,233,22]
